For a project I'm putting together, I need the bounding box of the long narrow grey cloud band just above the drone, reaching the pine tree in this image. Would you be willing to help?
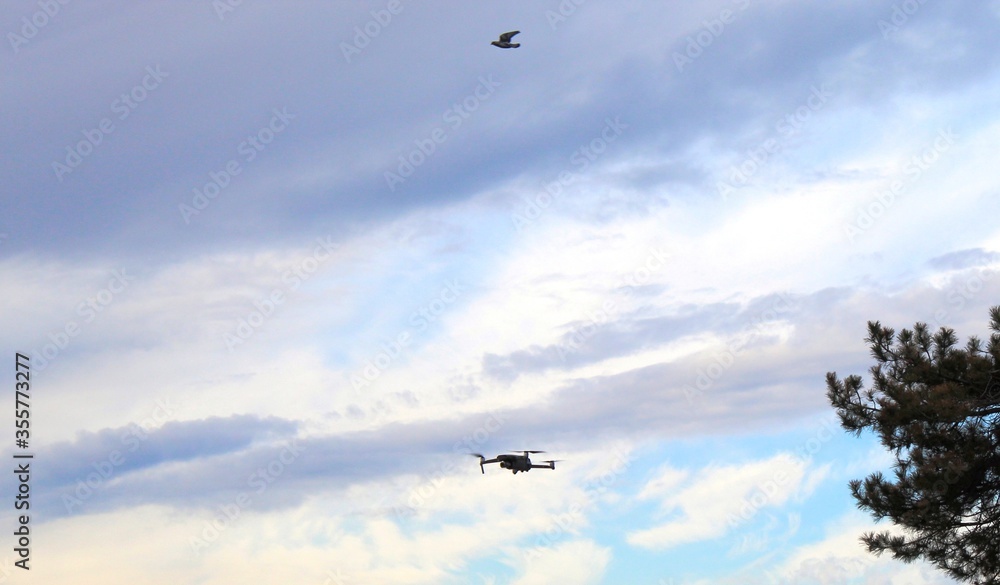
[11,262,1000,519]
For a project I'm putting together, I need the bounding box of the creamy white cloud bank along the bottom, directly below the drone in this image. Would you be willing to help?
[27,447,627,585]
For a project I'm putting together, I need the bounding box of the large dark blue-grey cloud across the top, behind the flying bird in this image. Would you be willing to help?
[0,1,1000,261]
